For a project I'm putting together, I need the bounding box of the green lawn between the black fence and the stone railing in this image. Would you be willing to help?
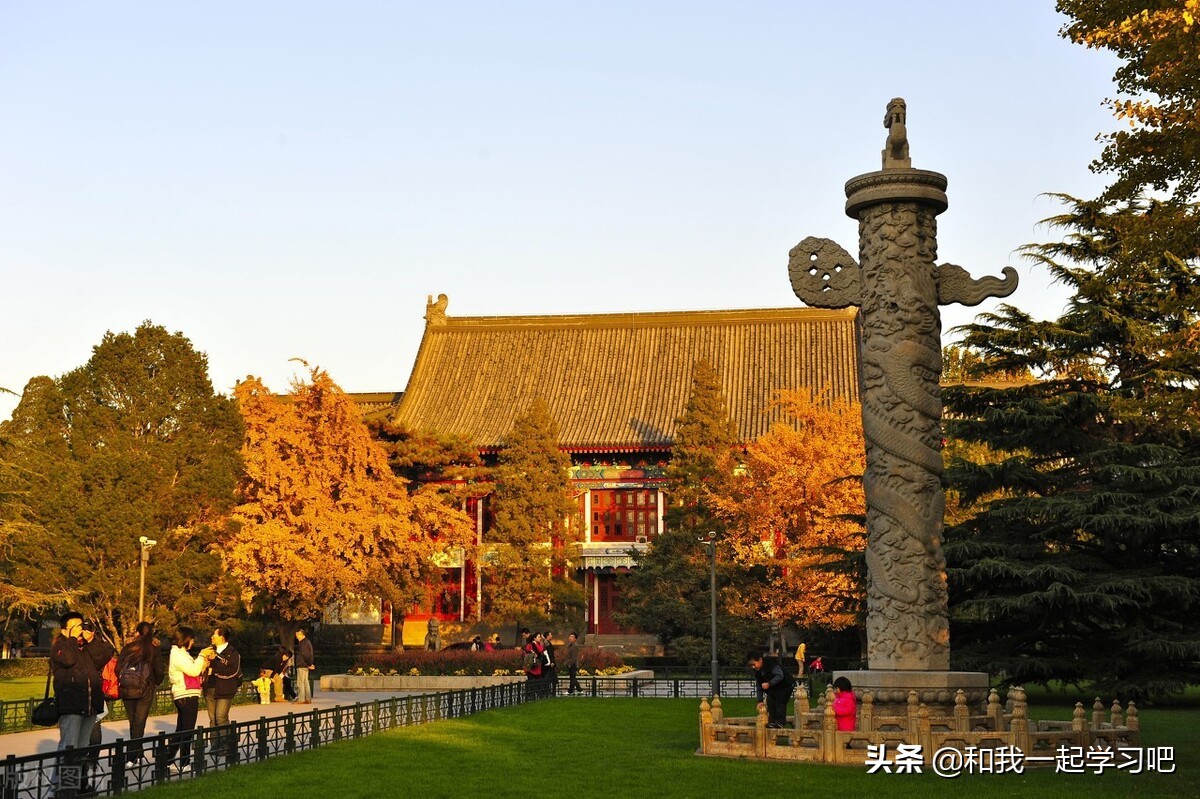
[139,698,1200,799]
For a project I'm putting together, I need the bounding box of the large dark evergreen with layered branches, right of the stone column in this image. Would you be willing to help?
[944,199,1200,696]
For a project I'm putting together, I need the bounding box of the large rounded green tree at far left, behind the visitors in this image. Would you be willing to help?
[0,322,241,642]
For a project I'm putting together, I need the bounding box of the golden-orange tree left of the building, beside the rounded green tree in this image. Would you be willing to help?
[224,368,474,641]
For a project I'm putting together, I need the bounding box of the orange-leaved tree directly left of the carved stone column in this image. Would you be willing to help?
[709,391,866,643]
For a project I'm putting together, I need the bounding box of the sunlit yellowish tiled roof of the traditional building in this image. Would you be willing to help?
[395,301,858,451]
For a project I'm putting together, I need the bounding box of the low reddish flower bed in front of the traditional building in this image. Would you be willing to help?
[348,647,634,677]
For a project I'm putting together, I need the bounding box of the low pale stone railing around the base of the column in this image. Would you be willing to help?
[698,685,1140,765]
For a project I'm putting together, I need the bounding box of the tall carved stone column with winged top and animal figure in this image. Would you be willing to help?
[788,97,1018,713]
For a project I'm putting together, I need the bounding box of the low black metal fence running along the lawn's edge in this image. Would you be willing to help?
[0,677,755,799]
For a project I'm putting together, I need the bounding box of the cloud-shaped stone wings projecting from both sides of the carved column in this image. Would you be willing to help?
[787,236,1018,308]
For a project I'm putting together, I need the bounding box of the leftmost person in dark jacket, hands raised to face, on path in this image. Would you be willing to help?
[50,611,104,793]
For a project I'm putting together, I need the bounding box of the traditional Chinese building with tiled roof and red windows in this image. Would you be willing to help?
[394,295,858,635]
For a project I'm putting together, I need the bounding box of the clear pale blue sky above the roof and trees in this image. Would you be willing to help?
[0,0,1116,417]
